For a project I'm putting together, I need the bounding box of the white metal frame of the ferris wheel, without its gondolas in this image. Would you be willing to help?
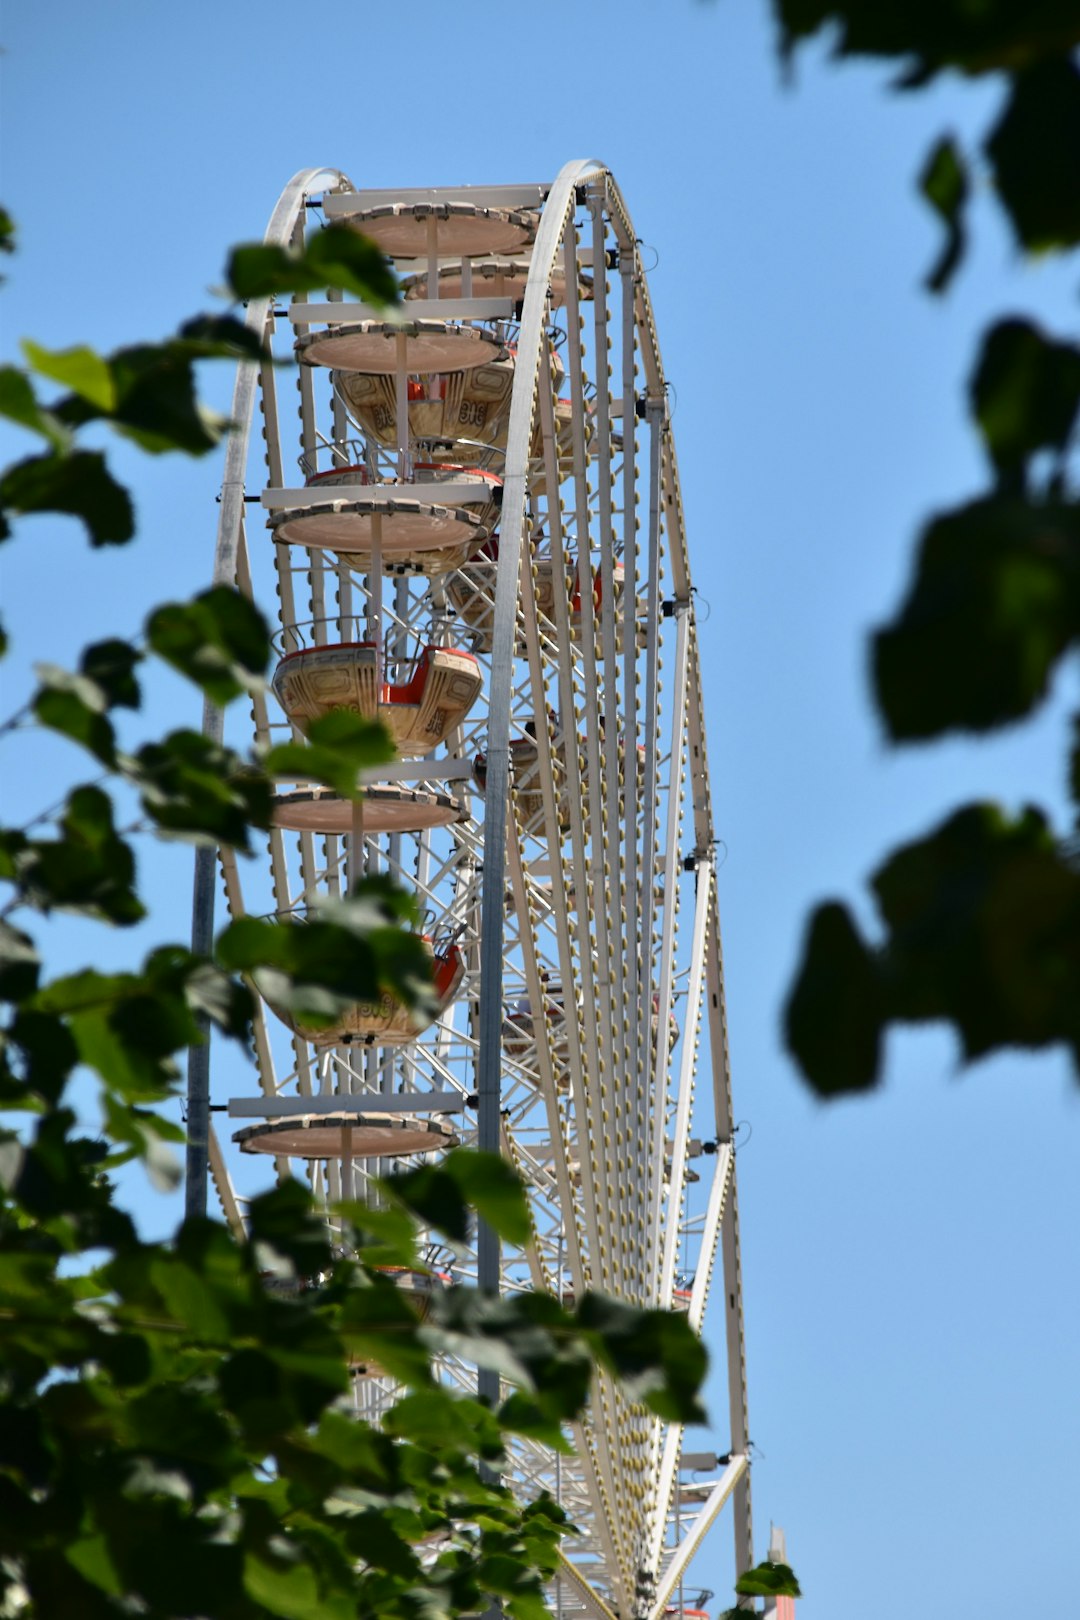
[188,159,755,1620]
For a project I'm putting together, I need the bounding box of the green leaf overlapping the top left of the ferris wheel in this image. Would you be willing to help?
[227,224,400,306]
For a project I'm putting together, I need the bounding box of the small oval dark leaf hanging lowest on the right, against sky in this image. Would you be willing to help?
[784,902,886,1097]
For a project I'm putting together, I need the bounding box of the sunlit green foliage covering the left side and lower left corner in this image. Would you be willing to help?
[0,215,718,1620]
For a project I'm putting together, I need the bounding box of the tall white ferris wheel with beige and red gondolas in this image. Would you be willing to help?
[191,160,753,1620]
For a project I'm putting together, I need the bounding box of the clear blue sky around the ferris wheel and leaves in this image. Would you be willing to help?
[0,0,1080,1620]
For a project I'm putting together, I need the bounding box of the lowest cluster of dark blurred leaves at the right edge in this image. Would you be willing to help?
[789,805,1080,1095]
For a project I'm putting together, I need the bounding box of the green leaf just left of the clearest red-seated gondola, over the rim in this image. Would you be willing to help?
[146,585,270,705]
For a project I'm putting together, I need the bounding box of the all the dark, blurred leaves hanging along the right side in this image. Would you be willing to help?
[774,0,1080,1097]
